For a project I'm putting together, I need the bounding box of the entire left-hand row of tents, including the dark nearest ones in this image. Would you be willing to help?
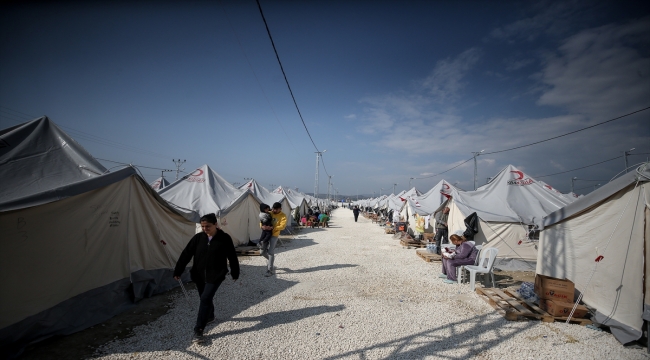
[0,117,324,358]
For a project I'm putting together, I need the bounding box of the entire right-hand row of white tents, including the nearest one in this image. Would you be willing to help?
[353,163,650,344]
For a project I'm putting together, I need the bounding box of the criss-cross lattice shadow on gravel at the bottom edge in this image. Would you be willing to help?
[325,313,539,360]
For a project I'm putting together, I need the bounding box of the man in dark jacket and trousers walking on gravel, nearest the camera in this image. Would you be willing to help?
[174,214,239,343]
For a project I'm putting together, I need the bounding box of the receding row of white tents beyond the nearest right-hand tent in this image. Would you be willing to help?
[358,165,576,270]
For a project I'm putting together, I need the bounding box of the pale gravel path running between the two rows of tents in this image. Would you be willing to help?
[95,209,647,359]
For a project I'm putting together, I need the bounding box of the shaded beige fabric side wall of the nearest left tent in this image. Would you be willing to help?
[0,176,194,329]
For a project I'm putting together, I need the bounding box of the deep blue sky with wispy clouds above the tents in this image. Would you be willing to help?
[0,0,650,195]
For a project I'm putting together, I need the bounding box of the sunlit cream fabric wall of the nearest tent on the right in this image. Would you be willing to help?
[537,183,650,340]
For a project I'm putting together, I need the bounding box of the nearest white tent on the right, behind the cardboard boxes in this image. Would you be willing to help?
[537,163,650,343]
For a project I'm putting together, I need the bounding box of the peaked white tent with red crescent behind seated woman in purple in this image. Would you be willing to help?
[439,165,569,270]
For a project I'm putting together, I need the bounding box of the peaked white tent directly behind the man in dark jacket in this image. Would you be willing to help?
[158,165,262,246]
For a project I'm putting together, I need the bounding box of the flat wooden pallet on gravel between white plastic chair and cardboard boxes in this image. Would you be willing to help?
[476,288,592,326]
